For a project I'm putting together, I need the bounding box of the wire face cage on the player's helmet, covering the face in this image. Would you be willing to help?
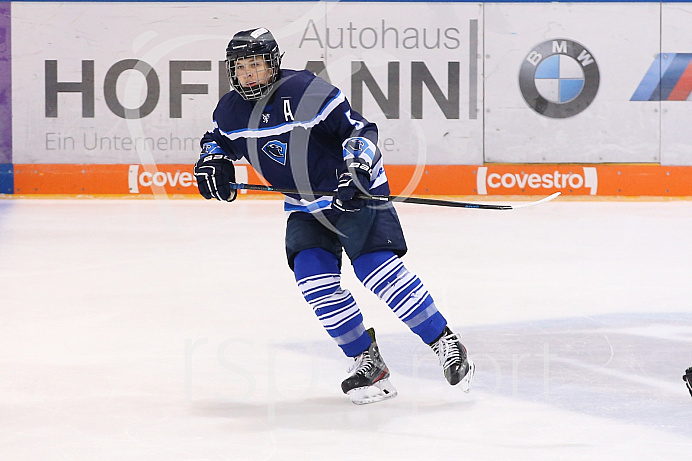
[226,47,281,101]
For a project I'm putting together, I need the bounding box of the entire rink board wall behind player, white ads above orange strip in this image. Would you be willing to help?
[0,1,692,196]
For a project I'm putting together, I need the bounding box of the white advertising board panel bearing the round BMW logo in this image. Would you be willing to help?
[484,3,660,163]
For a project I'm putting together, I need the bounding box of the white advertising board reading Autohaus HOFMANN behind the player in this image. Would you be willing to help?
[12,2,483,164]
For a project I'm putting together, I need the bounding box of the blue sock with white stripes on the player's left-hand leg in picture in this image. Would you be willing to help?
[294,248,372,357]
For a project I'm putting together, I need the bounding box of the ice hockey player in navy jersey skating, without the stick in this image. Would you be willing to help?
[194,28,474,404]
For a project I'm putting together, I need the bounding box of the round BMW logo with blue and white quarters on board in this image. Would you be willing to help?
[519,38,600,118]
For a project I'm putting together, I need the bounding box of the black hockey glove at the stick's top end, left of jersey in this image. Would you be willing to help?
[195,154,238,202]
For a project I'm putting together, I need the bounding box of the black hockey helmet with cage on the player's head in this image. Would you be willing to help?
[226,27,281,101]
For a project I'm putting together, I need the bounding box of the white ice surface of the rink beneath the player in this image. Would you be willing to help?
[0,196,692,461]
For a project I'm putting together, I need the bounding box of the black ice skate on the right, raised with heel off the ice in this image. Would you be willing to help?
[430,327,476,392]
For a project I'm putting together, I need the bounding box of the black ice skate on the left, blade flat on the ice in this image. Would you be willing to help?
[341,328,397,405]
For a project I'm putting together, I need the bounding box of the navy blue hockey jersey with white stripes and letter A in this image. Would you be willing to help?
[201,69,389,213]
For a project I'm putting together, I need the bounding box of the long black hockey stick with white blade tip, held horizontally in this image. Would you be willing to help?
[231,183,560,210]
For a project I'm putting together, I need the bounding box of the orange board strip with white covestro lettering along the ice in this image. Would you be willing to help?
[14,164,692,197]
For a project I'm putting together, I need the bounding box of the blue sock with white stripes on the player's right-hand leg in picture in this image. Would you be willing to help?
[353,251,447,344]
